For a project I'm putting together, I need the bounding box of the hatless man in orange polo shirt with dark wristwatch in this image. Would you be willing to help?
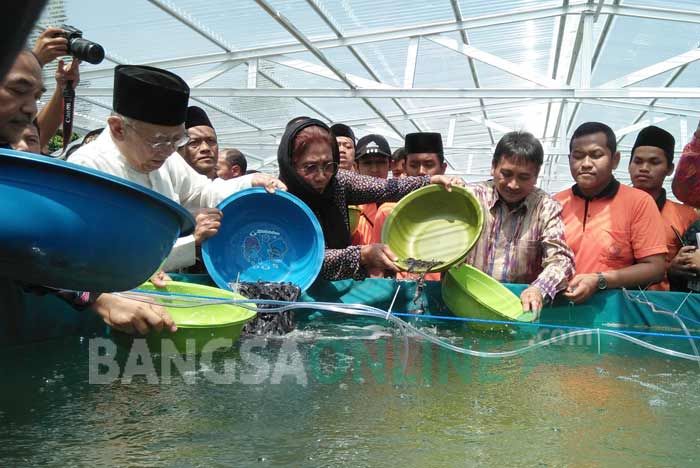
[554,122,668,303]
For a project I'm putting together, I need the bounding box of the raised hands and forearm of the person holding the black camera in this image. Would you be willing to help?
[33,28,80,152]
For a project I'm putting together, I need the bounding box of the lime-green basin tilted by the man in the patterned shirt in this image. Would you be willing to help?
[442,265,534,330]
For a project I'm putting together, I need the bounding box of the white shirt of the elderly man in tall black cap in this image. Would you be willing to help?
[69,127,253,271]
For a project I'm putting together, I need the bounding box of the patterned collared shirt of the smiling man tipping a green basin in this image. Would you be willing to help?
[466,181,574,298]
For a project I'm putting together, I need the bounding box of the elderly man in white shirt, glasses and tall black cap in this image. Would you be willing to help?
[69,65,286,332]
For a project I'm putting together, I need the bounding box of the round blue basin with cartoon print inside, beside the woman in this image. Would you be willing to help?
[202,188,324,291]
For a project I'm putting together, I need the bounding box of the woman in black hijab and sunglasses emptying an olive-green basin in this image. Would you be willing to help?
[277,119,464,280]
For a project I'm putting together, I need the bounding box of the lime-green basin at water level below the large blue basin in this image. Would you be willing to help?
[120,281,256,354]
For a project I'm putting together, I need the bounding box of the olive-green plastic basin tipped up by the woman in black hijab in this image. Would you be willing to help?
[382,185,484,271]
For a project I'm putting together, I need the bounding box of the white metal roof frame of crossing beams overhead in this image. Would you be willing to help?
[42,0,700,186]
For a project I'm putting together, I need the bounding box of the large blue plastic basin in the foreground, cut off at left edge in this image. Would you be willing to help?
[0,149,194,292]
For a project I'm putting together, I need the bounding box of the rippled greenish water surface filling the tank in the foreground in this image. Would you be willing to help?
[0,326,700,467]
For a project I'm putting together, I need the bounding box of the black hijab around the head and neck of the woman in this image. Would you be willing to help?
[277,118,350,249]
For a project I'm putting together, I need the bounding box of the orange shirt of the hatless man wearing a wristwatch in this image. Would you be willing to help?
[554,184,668,274]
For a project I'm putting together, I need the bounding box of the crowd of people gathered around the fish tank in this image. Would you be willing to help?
[0,22,700,334]
